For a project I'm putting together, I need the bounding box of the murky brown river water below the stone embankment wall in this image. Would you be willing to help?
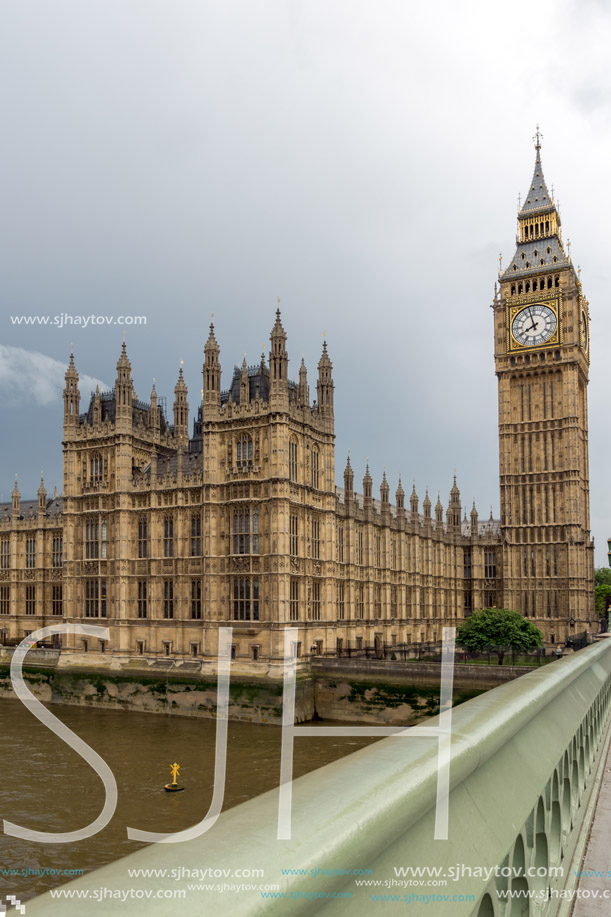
[0,700,374,900]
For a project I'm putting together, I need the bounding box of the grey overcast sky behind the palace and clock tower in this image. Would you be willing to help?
[0,0,611,564]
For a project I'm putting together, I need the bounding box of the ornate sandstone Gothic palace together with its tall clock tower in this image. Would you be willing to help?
[0,135,594,671]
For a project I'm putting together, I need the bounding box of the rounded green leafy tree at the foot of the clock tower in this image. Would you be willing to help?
[456,608,543,665]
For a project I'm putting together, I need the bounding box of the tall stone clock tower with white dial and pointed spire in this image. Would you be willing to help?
[493,128,594,643]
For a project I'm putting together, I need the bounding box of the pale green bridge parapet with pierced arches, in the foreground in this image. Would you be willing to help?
[27,641,611,917]
